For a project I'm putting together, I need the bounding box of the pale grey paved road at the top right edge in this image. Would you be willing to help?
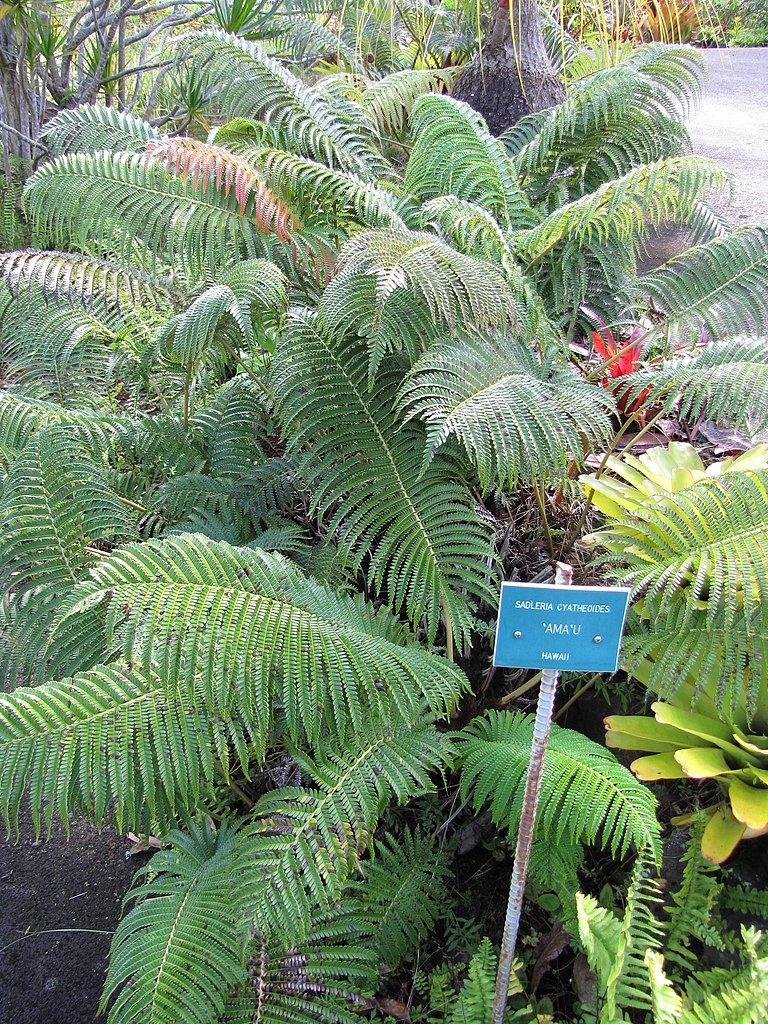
[689,47,768,225]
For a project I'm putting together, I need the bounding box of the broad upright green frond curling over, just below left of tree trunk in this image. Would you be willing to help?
[404,95,538,229]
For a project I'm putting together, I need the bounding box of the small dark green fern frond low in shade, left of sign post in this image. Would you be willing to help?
[361,829,451,968]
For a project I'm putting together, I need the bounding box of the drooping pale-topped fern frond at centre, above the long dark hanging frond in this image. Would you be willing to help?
[319,229,516,379]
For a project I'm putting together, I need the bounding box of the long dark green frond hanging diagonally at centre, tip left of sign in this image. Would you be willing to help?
[270,317,493,641]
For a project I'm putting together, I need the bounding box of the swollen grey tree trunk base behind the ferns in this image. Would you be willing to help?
[454,0,565,135]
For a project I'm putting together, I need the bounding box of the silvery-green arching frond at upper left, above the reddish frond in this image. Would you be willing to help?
[185,32,384,173]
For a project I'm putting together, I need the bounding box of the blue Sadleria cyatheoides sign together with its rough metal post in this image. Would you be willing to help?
[492,562,630,1024]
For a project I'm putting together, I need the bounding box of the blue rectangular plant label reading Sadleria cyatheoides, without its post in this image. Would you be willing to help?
[494,583,630,672]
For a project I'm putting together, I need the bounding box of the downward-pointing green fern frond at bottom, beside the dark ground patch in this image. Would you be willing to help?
[99,821,248,1024]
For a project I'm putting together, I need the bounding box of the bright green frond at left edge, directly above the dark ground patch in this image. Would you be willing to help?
[0,664,246,835]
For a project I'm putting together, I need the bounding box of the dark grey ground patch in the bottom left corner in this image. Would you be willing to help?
[0,821,144,1024]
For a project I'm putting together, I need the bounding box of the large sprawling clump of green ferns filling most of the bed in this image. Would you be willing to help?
[0,22,768,1024]
